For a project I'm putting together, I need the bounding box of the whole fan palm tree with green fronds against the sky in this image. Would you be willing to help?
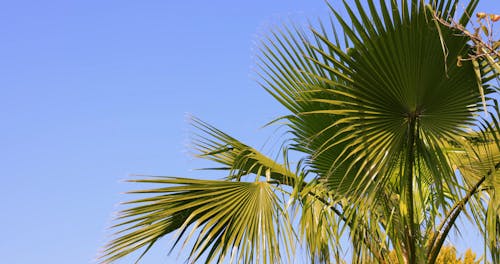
[101,0,500,263]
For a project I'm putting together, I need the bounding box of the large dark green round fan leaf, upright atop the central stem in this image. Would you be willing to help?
[306,1,481,200]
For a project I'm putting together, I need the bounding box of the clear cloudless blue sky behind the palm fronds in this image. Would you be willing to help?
[0,0,500,264]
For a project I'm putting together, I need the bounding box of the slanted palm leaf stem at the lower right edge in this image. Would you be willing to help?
[427,162,500,263]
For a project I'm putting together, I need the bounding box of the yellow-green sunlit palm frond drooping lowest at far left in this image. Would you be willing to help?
[99,177,293,263]
